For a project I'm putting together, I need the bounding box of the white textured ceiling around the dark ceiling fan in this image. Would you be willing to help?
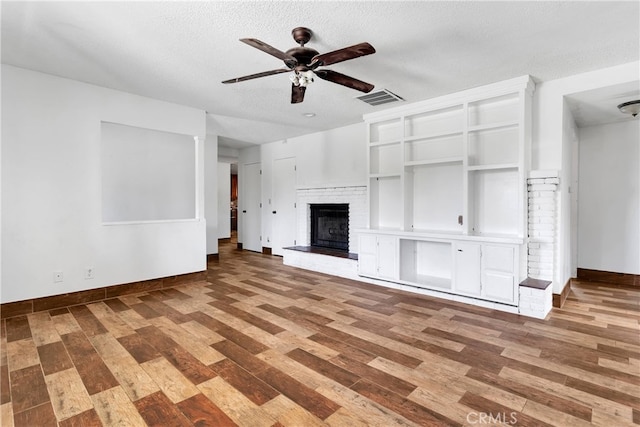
[1,1,640,147]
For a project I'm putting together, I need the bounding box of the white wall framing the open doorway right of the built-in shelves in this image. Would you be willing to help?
[531,62,640,293]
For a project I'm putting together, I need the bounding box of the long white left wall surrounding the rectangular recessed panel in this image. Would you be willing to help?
[0,65,206,303]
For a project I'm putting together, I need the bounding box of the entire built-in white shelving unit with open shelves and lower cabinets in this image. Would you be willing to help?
[359,76,534,305]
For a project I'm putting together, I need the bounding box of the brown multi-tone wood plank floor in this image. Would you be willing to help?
[0,239,640,427]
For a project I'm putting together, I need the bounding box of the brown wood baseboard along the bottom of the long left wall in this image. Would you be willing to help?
[0,271,207,319]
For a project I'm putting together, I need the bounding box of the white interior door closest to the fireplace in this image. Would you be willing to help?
[271,157,297,256]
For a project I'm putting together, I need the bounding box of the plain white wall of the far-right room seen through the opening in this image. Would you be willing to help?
[578,119,640,274]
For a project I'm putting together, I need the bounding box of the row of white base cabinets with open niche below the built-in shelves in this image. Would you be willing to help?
[358,231,520,306]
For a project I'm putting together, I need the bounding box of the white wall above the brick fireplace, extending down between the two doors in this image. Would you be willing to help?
[255,123,367,247]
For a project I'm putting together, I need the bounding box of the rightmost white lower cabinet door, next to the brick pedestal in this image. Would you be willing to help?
[482,244,518,304]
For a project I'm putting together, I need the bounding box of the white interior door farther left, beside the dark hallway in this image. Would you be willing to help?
[239,163,262,252]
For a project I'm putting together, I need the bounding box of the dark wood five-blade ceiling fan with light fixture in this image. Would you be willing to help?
[222,27,376,104]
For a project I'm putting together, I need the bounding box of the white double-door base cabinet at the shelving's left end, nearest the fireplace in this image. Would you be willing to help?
[358,234,398,280]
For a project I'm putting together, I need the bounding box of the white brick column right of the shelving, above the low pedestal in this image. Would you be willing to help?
[527,171,560,280]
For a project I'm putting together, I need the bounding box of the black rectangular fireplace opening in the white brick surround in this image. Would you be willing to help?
[310,203,349,252]
